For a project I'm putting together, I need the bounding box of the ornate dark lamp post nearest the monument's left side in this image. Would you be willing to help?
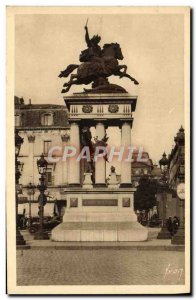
[34,154,49,240]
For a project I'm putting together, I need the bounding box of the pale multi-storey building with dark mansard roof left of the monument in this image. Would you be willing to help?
[15,97,69,216]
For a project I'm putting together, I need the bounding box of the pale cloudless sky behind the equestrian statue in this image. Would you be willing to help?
[15,14,184,162]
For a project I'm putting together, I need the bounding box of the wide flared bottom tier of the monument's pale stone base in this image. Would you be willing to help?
[51,218,148,242]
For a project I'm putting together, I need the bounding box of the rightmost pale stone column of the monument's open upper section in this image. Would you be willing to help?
[121,122,131,187]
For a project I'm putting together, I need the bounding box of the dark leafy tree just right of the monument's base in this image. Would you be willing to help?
[134,175,157,212]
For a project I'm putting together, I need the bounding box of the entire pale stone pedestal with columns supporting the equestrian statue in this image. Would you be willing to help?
[51,93,148,242]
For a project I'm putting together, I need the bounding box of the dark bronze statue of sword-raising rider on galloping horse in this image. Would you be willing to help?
[59,20,139,93]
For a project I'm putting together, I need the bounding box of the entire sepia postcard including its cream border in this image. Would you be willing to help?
[6,6,191,295]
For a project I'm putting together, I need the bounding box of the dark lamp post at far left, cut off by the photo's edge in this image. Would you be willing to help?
[15,130,26,246]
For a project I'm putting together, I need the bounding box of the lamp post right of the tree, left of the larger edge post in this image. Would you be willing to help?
[157,152,171,239]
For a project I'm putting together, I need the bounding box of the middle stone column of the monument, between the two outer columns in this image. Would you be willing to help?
[95,122,106,186]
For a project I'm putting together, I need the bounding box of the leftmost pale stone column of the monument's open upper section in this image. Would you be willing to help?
[68,123,80,185]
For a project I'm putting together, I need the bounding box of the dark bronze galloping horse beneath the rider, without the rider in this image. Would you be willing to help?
[59,43,139,93]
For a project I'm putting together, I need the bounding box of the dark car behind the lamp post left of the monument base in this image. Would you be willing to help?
[29,217,62,233]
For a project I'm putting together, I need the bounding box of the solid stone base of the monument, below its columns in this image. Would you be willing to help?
[51,188,148,242]
